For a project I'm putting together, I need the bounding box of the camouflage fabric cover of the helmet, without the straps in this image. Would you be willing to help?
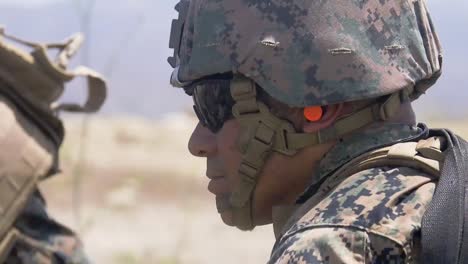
[170,0,441,107]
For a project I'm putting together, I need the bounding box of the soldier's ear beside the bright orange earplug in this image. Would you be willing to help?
[302,103,344,133]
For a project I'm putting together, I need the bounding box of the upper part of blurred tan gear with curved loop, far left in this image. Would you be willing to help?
[0,27,106,113]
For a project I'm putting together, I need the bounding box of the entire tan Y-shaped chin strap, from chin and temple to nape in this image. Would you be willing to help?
[221,75,410,230]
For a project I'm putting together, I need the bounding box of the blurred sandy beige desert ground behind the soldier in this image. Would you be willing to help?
[40,113,468,264]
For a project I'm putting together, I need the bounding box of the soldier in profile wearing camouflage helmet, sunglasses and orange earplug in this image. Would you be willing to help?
[169,0,467,263]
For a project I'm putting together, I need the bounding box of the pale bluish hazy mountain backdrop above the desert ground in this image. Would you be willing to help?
[0,0,468,117]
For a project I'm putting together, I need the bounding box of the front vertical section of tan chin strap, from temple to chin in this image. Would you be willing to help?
[229,77,296,230]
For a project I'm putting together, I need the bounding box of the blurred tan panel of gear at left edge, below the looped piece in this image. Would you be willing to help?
[0,95,58,256]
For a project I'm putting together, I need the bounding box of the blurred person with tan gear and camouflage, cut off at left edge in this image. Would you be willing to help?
[0,27,106,264]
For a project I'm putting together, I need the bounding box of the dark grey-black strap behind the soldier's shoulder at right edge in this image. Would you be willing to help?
[421,130,468,263]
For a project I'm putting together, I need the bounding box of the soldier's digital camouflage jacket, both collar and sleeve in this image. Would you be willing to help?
[269,124,435,263]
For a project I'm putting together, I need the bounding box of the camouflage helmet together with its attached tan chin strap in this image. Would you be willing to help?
[168,0,442,229]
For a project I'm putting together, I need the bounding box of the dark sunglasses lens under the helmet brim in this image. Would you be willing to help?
[192,80,234,133]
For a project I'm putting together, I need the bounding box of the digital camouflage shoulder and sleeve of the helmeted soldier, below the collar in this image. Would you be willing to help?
[270,167,435,263]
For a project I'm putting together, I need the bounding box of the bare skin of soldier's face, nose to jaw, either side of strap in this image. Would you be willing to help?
[189,119,320,225]
